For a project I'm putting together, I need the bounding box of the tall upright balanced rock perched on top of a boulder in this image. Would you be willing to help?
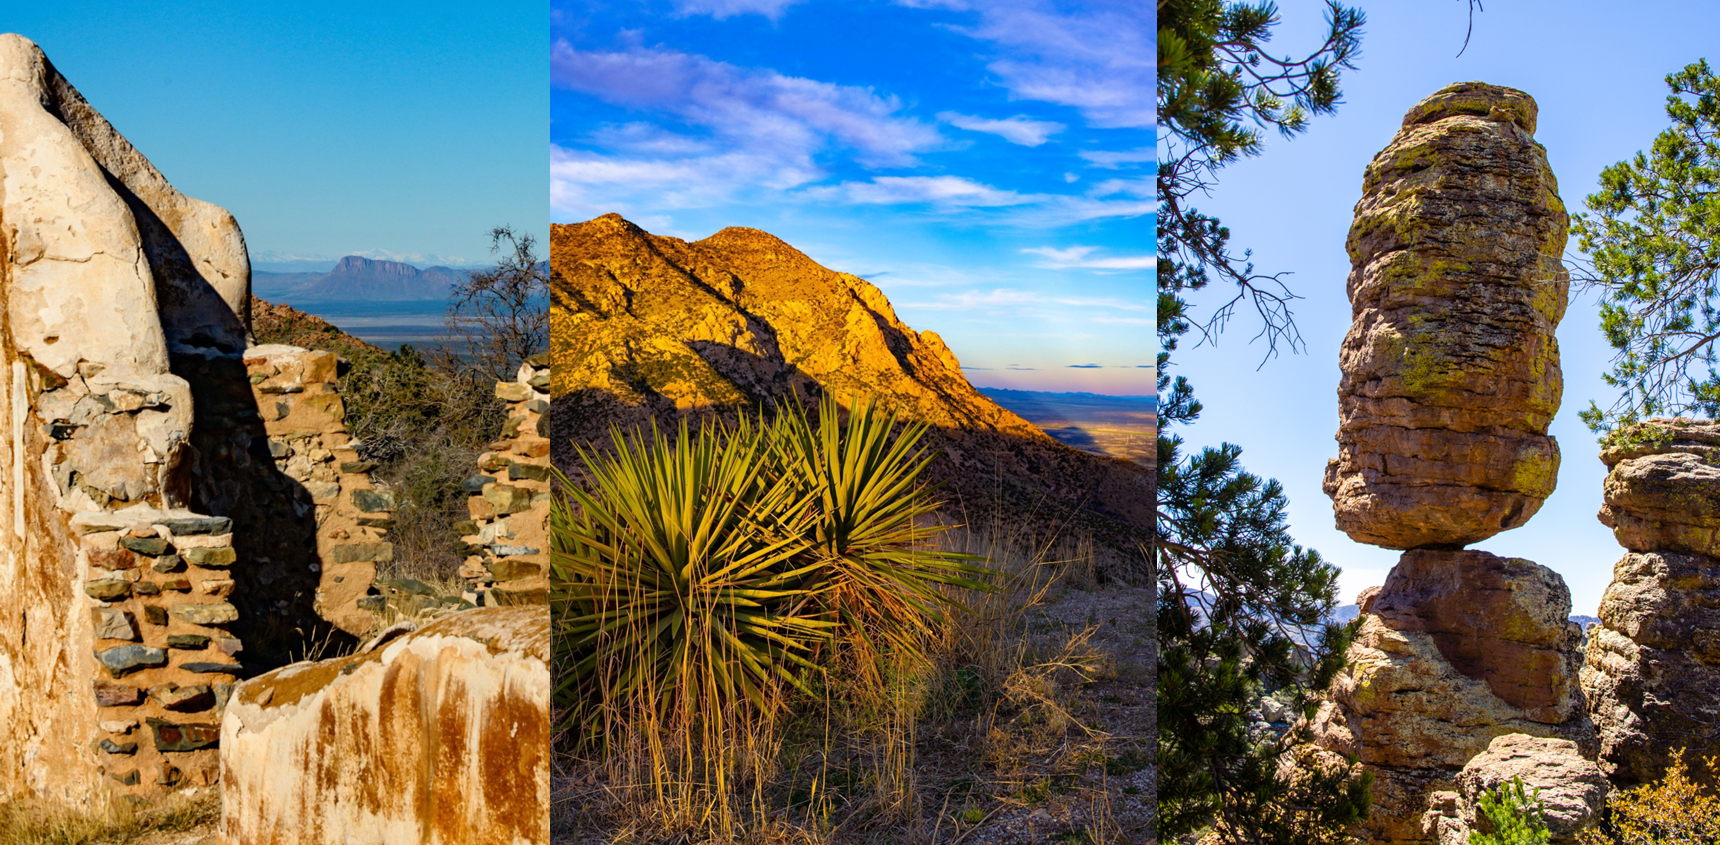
[1324,83,1569,549]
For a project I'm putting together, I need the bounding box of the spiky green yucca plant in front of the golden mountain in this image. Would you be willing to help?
[550,398,987,747]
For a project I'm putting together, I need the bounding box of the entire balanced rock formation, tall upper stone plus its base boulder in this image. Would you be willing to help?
[1311,83,1596,843]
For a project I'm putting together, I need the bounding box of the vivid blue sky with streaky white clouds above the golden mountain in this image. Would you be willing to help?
[550,0,1154,396]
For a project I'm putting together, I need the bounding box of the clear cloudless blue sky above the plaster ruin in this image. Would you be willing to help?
[0,0,549,262]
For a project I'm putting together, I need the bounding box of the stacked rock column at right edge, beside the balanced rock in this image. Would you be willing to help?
[1582,420,1720,785]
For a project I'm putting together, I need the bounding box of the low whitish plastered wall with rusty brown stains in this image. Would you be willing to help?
[220,606,550,845]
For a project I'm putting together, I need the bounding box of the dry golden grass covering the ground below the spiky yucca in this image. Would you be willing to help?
[552,528,1149,845]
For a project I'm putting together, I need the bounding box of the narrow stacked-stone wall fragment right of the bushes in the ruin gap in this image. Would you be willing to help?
[461,355,550,604]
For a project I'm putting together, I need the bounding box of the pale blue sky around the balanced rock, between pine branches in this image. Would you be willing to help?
[1178,0,1720,614]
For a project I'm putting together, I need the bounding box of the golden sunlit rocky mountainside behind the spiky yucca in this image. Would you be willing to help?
[550,213,1151,578]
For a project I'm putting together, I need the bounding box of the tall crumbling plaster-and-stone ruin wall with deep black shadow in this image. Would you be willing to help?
[0,34,409,804]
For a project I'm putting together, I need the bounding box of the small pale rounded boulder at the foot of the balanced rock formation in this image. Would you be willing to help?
[1426,733,1612,845]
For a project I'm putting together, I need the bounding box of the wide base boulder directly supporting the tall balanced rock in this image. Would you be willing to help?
[1311,551,1594,843]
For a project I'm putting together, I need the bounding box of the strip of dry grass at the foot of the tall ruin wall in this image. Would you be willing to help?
[0,792,220,845]
